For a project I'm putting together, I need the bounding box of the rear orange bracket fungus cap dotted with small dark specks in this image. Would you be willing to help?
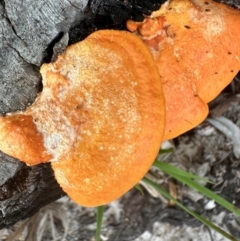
[127,0,240,139]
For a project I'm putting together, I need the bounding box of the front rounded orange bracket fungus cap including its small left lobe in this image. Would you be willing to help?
[0,30,165,206]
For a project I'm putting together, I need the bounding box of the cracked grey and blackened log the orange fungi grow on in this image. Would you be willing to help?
[0,0,240,228]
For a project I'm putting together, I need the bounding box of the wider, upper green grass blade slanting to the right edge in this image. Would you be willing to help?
[154,161,240,216]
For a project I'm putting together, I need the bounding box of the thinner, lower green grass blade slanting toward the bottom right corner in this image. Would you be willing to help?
[142,177,238,241]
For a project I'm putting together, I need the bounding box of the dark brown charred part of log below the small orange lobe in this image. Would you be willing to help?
[0,161,65,228]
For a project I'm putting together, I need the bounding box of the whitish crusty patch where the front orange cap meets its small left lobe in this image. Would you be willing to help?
[28,87,77,161]
